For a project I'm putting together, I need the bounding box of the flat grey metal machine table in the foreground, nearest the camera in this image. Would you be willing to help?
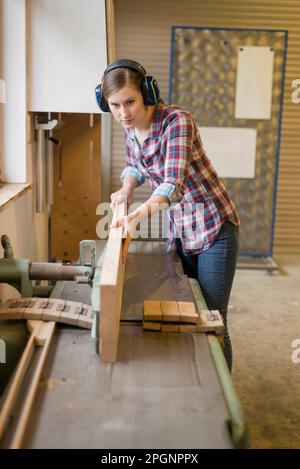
[23,325,232,448]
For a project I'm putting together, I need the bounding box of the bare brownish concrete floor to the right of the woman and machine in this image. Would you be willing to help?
[229,255,300,448]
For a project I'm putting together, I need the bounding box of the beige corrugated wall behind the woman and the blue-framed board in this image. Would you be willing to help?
[112,0,300,253]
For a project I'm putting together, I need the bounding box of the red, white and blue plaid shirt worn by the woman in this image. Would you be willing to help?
[120,100,239,255]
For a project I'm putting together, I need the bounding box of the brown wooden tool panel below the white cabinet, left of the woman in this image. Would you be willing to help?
[50,114,101,261]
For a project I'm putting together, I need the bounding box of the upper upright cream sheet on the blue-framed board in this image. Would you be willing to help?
[235,46,274,119]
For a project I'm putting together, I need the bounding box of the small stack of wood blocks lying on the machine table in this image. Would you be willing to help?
[143,300,224,334]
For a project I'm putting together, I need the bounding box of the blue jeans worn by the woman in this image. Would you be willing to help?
[176,221,239,370]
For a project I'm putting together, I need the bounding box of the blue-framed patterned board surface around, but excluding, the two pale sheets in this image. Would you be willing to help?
[169,26,287,256]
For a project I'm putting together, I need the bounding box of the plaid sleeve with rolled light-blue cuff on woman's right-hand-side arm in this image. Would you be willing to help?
[152,113,194,205]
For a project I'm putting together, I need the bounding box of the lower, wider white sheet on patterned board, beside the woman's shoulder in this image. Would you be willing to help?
[199,127,257,178]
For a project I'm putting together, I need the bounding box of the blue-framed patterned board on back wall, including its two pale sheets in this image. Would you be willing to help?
[171,27,287,256]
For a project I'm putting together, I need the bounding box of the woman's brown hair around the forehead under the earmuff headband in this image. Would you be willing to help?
[102,67,144,101]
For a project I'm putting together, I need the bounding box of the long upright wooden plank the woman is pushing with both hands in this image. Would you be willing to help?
[99,204,126,362]
